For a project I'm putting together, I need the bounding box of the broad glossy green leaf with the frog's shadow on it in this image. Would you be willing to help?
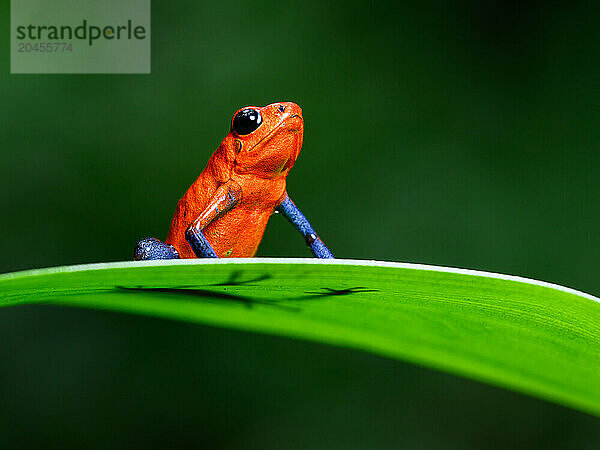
[0,258,600,415]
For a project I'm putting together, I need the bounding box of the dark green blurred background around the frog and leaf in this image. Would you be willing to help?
[0,0,600,449]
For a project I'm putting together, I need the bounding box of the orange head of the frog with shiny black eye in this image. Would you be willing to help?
[223,102,304,179]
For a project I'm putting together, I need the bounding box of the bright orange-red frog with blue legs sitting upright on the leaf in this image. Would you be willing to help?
[134,102,334,260]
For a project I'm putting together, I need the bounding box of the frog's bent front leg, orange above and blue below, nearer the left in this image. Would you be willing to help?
[185,180,242,258]
